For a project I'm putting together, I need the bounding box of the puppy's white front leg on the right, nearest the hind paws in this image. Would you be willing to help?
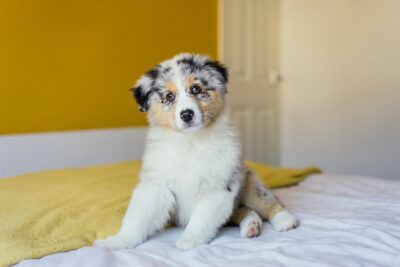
[176,190,237,249]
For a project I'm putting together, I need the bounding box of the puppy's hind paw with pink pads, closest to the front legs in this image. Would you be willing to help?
[231,207,262,238]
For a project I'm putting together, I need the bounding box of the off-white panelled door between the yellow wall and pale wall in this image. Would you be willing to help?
[219,0,279,165]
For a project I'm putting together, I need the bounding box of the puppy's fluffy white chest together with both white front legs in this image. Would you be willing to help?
[95,107,243,249]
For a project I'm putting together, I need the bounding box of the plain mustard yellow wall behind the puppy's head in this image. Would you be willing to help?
[0,0,217,134]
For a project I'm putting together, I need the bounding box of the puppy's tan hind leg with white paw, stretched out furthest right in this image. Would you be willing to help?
[241,171,298,232]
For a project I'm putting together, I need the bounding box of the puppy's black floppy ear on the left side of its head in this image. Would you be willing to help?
[131,68,158,112]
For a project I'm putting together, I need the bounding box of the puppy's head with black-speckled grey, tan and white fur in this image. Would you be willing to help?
[132,54,228,131]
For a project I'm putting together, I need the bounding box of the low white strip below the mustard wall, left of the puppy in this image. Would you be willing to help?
[0,127,146,178]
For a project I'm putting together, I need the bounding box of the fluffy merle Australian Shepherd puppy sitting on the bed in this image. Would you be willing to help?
[95,54,298,249]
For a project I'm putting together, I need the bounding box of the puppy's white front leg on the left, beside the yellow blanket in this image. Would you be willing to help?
[94,182,175,249]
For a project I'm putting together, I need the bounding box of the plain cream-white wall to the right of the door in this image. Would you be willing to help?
[280,0,400,179]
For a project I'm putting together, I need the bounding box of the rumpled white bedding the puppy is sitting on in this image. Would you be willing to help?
[17,175,400,267]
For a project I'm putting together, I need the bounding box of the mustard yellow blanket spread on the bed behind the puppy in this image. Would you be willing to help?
[0,161,319,266]
